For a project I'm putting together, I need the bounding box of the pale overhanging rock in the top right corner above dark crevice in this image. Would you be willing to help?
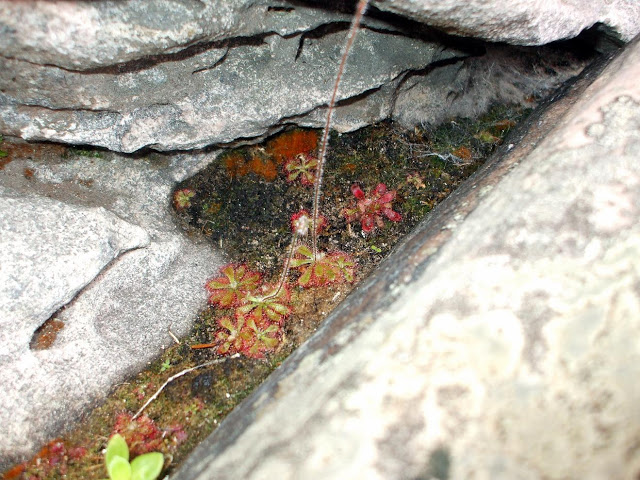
[371,0,640,45]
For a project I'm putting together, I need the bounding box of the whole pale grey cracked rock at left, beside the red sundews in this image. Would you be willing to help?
[0,146,221,469]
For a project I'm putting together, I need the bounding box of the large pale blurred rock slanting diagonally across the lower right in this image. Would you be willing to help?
[172,34,640,480]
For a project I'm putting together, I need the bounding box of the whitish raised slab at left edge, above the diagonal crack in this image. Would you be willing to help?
[0,192,150,363]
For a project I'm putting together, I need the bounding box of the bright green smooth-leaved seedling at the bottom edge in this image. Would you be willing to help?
[104,433,164,480]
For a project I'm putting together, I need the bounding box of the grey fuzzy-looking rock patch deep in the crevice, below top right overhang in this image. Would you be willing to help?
[392,45,586,129]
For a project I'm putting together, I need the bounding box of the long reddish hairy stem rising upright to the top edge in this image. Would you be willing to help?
[311,0,369,261]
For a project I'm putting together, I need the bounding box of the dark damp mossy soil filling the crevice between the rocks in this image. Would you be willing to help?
[0,105,528,480]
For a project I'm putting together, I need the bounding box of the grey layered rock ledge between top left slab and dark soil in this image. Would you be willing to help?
[0,24,466,152]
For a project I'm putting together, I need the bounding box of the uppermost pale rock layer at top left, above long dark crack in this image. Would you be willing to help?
[0,0,349,70]
